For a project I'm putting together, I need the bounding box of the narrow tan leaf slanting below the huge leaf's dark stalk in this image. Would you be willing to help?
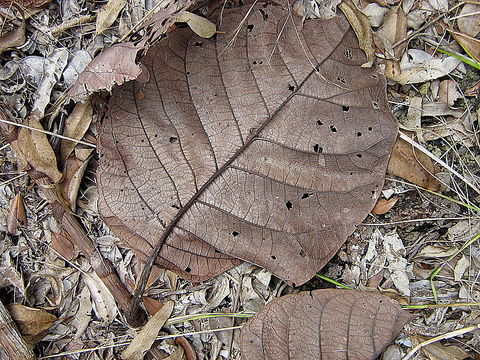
[122,301,174,360]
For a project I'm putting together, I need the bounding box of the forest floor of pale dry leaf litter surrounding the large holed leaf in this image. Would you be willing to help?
[0,0,480,360]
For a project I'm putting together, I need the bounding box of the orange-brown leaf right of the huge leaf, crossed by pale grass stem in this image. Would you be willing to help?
[387,138,440,191]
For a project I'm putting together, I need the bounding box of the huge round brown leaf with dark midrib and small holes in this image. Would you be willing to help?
[98,3,397,284]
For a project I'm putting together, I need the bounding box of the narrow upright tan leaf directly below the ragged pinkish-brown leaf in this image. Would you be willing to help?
[60,100,93,164]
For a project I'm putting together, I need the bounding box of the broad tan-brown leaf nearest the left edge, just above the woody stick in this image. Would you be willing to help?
[12,115,63,183]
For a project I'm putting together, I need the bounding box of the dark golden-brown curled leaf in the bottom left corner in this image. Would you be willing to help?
[6,303,57,345]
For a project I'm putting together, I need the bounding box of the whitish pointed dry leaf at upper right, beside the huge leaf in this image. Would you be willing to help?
[392,49,461,85]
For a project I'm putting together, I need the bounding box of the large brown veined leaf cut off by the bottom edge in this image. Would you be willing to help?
[241,289,412,360]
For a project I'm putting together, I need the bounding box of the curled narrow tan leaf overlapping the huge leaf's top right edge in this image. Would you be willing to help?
[338,0,375,67]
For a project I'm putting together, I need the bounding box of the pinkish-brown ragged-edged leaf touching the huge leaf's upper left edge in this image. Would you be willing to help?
[69,42,142,102]
